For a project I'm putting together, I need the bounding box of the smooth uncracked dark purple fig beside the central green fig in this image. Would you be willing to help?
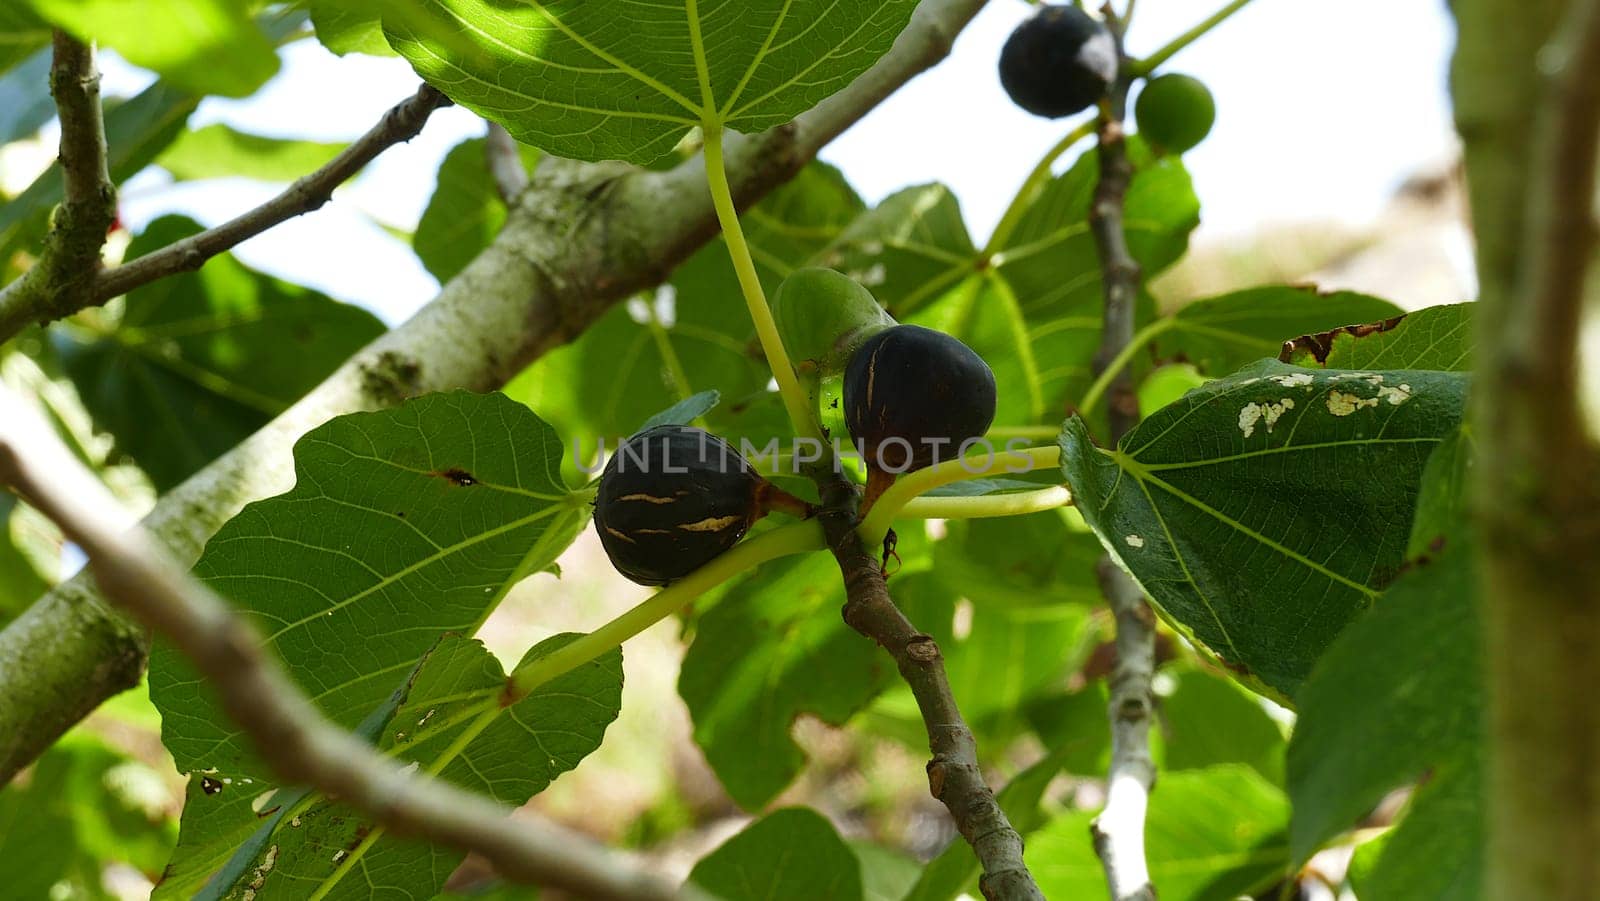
[845,325,995,480]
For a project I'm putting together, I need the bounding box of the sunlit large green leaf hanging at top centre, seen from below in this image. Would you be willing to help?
[382,0,917,165]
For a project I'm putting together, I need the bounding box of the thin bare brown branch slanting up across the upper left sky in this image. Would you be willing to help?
[0,82,450,342]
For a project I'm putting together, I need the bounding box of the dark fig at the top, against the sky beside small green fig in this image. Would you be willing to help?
[1000,6,1117,118]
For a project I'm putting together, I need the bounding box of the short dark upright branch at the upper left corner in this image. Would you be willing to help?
[0,29,117,344]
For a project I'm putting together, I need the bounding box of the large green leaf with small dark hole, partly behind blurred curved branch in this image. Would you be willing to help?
[150,392,587,891]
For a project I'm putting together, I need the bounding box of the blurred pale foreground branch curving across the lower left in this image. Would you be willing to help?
[0,389,707,901]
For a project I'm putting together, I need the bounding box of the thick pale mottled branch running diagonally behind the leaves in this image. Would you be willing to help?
[0,0,984,783]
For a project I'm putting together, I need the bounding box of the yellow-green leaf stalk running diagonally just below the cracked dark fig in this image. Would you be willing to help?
[506,520,824,703]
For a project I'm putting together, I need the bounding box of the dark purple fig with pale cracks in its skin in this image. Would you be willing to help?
[595,426,805,586]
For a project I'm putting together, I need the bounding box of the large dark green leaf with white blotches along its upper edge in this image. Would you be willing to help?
[1061,360,1467,698]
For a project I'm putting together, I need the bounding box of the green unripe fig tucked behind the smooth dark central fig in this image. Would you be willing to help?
[773,266,894,373]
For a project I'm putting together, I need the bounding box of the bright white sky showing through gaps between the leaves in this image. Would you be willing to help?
[0,0,1454,323]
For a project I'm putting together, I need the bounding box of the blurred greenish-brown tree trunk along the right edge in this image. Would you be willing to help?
[1451,0,1600,901]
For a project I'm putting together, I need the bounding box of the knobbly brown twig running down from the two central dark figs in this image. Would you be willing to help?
[814,466,1045,901]
